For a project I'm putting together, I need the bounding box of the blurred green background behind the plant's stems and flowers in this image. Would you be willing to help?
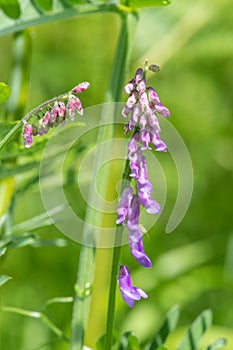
[0,0,233,350]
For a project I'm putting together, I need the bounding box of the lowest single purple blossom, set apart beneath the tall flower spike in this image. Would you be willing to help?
[118,265,147,307]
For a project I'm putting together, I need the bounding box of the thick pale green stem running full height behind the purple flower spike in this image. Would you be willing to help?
[70,13,136,350]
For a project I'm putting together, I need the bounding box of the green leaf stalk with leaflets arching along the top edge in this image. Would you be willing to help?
[0,0,170,36]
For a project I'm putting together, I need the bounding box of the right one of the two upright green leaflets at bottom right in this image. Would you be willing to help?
[176,310,213,350]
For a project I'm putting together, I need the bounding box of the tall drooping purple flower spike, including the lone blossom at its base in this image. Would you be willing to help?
[116,68,170,307]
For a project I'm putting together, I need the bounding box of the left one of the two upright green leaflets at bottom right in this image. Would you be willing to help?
[145,305,180,350]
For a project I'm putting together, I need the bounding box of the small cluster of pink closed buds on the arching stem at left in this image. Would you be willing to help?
[23,82,90,148]
